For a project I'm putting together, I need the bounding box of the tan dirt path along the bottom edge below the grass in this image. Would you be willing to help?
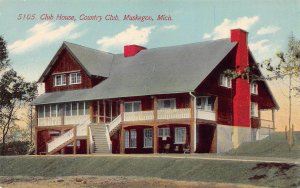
[0,176,262,188]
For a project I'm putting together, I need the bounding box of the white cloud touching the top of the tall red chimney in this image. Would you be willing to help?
[203,16,259,40]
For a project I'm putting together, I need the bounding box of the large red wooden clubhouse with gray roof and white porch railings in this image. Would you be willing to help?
[33,29,278,154]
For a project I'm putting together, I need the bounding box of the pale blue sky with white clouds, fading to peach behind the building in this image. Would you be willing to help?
[0,0,300,130]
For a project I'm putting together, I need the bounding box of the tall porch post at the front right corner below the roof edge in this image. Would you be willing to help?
[190,95,196,153]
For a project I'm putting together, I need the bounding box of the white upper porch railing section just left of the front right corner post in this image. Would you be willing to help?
[157,108,191,119]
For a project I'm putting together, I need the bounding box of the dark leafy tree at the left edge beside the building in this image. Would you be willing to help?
[0,37,37,155]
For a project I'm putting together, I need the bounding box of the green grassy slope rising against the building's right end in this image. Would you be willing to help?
[226,132,300,159]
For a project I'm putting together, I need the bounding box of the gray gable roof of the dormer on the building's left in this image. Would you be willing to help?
[38,42,113,82]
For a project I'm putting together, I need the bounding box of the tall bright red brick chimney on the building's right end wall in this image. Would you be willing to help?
[231,29,251,127]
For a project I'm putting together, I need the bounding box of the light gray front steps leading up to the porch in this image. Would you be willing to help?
[90,124,111,153]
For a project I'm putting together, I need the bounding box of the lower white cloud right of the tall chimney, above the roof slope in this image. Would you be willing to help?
[249,39,272,61]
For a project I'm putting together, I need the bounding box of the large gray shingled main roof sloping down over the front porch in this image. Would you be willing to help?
[34,39,236,104]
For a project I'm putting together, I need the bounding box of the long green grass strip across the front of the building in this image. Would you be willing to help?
[0,156,300,187]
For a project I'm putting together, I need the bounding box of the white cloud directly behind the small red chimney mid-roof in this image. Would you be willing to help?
[97,25,155,51]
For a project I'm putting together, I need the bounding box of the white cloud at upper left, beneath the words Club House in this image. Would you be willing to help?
[8,21,82,54]
